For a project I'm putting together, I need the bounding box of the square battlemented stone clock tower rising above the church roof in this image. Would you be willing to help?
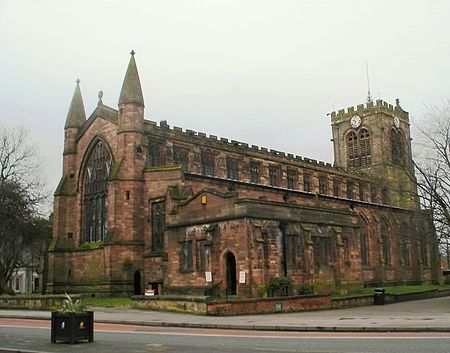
[331,99,419,208]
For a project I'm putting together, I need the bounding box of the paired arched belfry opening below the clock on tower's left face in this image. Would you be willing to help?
[347,129,372,167]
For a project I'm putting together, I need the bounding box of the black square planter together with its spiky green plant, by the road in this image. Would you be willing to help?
[51,293,94,344]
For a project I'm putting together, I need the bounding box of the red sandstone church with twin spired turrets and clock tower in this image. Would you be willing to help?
[47,52,438,298]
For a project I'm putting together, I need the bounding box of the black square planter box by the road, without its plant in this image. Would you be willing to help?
[51,311,94,344]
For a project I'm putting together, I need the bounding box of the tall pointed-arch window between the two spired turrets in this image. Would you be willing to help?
[83,141,112,242]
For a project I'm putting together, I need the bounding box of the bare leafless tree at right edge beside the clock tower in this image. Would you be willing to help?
[414,102,450,263]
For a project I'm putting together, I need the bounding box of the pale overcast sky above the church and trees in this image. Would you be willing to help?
[0,0,450,198]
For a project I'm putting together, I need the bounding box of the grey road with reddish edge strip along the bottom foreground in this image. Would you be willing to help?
[0,319,450,353]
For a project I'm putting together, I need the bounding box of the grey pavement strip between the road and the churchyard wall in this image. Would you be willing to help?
[0,297,450,332]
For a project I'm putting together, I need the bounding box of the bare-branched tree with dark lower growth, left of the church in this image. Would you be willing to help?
[0,127,50,294]
